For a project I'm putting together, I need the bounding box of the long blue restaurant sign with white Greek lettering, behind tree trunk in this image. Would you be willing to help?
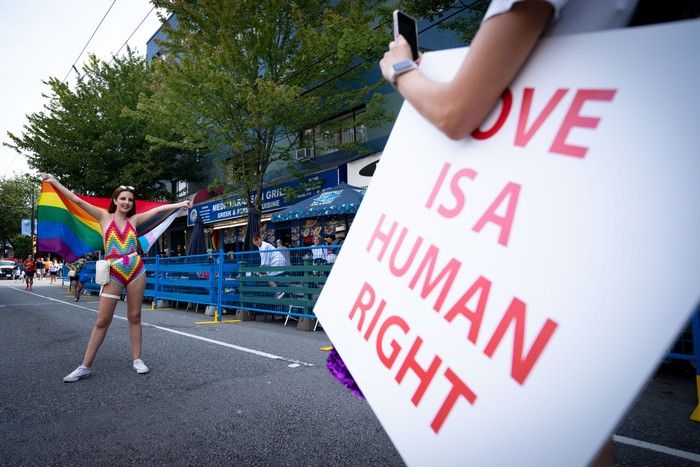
[187,169,339,226]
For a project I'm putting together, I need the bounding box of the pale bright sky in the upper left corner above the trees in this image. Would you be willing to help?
[0,0,168,178]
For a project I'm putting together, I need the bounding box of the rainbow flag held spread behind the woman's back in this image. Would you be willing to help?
[37,182,179,262]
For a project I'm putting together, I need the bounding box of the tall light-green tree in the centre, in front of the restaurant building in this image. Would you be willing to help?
[139,0,390,229]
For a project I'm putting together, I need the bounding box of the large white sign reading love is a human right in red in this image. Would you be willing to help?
[315,21,700,466]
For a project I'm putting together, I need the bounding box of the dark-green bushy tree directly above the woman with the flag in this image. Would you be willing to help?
[8,50,200,199]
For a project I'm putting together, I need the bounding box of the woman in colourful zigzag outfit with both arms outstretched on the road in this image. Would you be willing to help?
[41,173,190,383]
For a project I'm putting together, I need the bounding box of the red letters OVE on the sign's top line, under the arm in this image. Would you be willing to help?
[472,88,617,158]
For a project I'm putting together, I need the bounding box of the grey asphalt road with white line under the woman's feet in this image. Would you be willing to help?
[0,281,700,466]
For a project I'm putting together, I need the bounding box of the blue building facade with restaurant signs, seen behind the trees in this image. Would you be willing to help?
[142,2,479,251]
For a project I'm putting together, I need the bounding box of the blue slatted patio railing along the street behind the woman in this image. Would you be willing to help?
[76,245,340,328]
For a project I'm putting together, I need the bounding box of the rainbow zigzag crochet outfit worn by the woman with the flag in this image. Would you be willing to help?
[104,219,146,287]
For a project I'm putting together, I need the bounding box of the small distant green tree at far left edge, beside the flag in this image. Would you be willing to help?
[0,175,38,256]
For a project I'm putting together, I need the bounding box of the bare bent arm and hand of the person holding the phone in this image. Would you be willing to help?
[379,0,554,140]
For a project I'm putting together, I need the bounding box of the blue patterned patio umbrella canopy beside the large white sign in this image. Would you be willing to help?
[272,183,365,222]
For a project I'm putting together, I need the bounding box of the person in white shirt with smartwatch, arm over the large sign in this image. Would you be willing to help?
[379,0,637,140]
